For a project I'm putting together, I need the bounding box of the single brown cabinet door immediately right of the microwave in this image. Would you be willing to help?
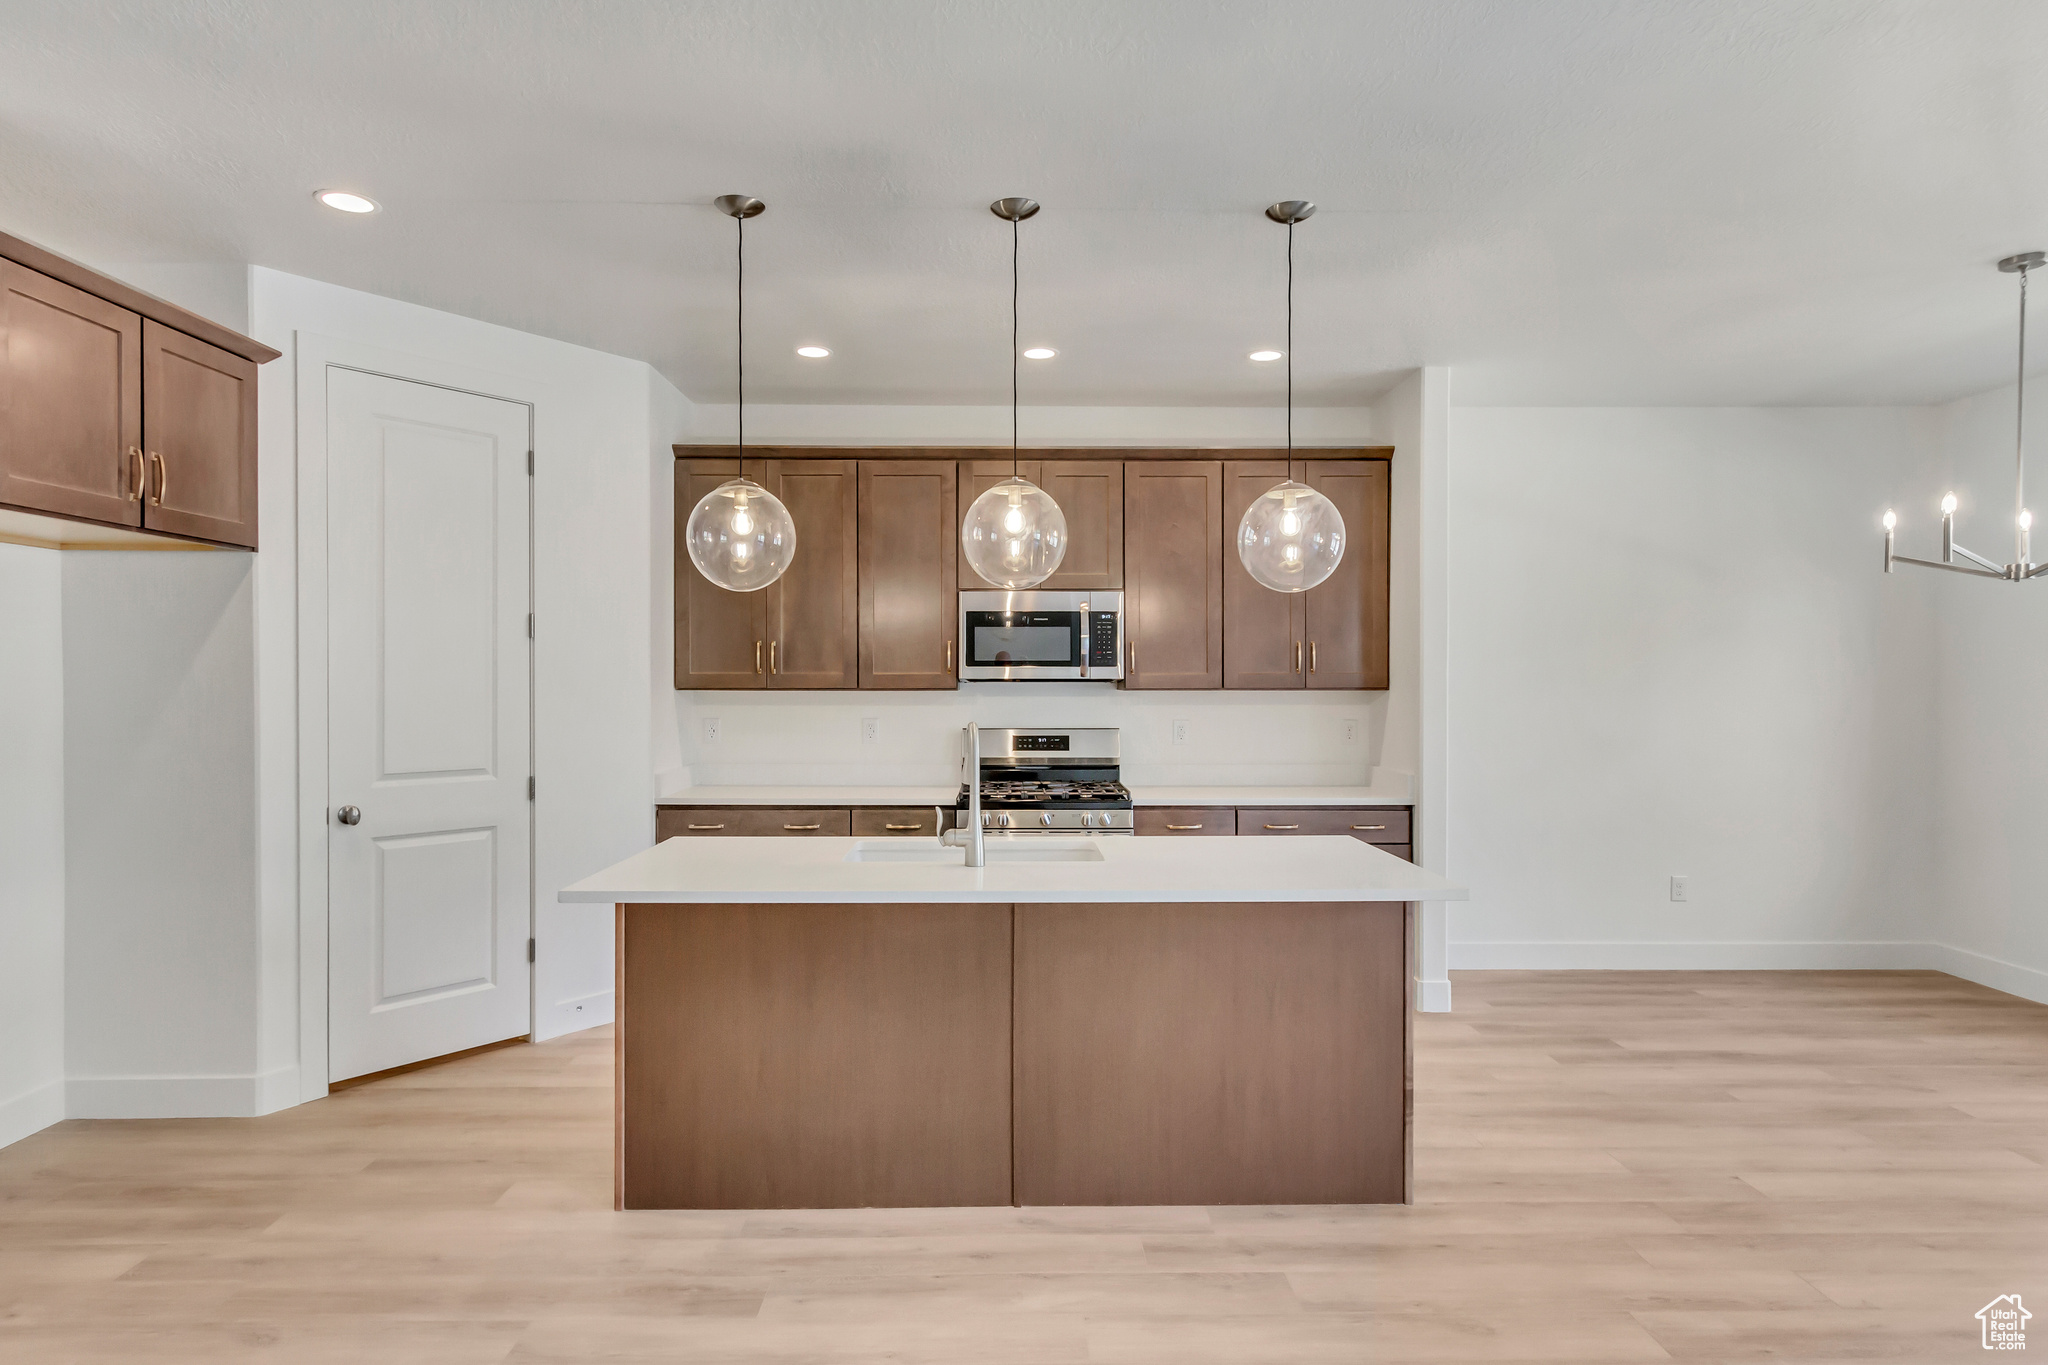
[1124,460,1223,688]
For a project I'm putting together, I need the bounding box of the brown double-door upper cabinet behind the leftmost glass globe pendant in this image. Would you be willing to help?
[676,458,860,690]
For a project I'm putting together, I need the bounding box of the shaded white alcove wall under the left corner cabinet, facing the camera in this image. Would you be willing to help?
[63,551,274,1117]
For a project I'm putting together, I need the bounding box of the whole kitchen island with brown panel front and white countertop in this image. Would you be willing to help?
[561,835,1464,1207]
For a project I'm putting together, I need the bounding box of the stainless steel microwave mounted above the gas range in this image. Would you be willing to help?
[961,589,1124,681]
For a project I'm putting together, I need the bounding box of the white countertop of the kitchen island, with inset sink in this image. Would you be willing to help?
[559,835,1466,905]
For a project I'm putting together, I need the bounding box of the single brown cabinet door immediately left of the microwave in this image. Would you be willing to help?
[860,460,961,688]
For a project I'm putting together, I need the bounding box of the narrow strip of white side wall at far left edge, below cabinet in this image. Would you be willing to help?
[0,544,63,1146]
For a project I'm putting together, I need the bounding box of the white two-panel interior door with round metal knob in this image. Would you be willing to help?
[326,366,532,1081]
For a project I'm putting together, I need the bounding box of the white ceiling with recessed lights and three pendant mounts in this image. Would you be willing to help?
[0,0,2048,405]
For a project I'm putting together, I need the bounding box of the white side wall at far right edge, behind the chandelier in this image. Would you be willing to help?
[1925,381,2048,1001]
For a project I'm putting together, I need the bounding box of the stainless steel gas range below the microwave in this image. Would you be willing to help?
[952,729,1135,835]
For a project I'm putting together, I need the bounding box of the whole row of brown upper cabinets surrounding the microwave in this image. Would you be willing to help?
[674,446,1395,692]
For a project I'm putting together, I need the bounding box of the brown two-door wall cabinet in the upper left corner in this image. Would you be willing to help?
[0,233,279,551]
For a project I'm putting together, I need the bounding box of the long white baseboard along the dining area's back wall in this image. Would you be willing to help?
[1450,939,1946,972]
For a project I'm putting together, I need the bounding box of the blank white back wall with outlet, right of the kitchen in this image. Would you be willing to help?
[1448,407,1941,968]
